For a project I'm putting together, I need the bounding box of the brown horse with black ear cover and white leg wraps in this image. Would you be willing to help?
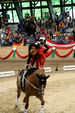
[16,68,50,113]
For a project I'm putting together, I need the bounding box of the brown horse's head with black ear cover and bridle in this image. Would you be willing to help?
[37,74,50,95]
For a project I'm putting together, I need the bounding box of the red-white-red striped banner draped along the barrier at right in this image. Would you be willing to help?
[46,38,75,49]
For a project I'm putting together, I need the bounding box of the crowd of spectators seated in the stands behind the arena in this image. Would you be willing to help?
[0,13,75,46]
